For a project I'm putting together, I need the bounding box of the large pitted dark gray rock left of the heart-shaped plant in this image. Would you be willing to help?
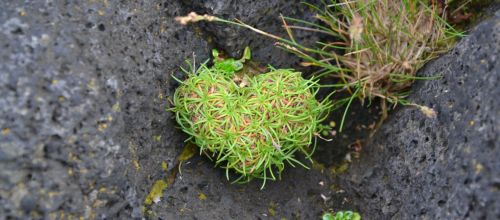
[0,1,208,219]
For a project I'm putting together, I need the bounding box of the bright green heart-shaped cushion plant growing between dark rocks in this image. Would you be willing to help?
[173,61,329,183]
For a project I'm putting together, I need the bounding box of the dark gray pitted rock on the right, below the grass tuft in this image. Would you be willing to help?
[342,11,500,219]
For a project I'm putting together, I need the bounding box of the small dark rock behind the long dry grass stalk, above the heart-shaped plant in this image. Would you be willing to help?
[183,0,319,68]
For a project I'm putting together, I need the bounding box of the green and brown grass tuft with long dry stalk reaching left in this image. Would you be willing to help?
[178,0,461,130]
